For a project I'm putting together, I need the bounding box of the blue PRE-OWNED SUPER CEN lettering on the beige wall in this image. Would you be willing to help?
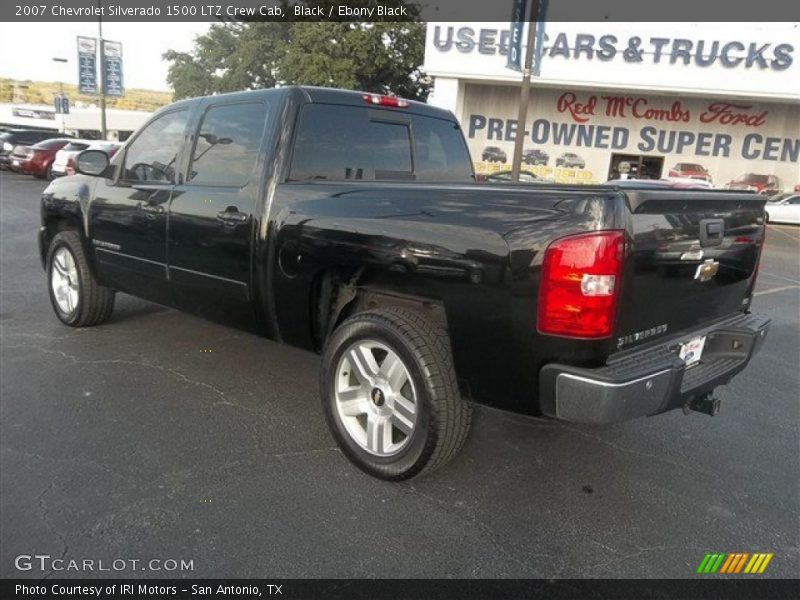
[467,114,800,163]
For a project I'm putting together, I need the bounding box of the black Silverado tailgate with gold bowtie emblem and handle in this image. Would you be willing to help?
[615,190,766,349]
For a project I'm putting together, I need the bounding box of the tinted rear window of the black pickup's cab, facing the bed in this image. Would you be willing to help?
[289,104,472,181]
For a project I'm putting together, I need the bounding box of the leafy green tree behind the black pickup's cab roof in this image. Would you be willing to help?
[164,6,430,100]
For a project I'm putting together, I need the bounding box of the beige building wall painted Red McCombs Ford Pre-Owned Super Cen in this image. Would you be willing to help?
[460,82,800,186]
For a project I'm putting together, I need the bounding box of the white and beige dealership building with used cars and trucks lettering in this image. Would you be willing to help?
[425,22,800,190]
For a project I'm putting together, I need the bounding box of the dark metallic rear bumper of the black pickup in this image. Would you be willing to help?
[539,314,770,423]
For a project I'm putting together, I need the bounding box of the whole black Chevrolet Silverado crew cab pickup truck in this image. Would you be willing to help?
[39,87,769,480]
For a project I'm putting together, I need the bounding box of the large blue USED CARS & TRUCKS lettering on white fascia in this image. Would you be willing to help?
[433,25,795,71]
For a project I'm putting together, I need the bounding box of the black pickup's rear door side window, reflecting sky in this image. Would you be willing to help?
[187,102,268,187]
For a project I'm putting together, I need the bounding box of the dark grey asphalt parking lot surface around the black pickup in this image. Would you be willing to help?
[0,172,800,578]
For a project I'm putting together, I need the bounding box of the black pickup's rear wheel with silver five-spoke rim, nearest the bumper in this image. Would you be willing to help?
[320,307,471,481]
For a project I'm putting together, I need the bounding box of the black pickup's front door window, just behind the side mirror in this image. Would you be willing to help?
[122,109,188,183]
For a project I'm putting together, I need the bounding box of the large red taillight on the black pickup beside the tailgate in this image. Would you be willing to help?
[538,231,625,338]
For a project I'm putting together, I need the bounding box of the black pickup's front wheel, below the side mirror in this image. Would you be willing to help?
[47,231,114,327]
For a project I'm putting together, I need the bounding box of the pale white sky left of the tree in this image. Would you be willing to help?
[0,21,211,91]
